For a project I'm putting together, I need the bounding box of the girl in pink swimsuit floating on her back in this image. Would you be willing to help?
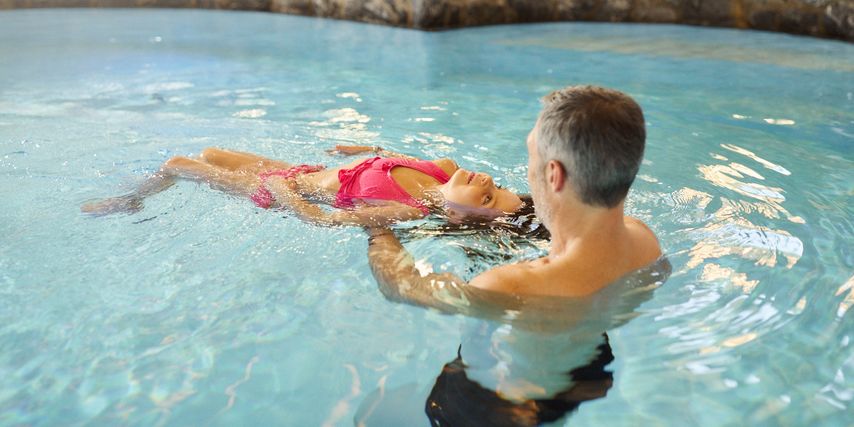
[81,145,523,226]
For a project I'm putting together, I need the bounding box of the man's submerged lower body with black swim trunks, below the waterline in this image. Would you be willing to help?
[354,249,671,426]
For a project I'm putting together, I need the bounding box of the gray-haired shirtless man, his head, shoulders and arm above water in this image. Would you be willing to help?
[368,86,661,311]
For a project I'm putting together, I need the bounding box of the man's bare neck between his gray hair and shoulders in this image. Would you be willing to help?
[549,203,625,260]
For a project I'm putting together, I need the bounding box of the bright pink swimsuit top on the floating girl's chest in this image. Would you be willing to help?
[335,157,450,215]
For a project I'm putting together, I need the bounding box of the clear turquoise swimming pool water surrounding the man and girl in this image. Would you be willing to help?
[0,10,854,426]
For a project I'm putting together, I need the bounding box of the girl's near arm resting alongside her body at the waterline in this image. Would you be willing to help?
[277,184,424,227]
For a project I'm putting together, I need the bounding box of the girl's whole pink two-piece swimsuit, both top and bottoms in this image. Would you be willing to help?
[250,157,451,214]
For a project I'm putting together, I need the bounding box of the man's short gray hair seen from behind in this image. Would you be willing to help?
[536,86,646,208]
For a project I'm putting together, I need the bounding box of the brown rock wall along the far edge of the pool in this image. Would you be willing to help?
[0,0,854,41]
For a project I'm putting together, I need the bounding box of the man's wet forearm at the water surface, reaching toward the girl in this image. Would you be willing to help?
[367,228,469,313]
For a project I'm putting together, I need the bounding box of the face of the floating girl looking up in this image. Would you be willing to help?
[439,168,523,213]
